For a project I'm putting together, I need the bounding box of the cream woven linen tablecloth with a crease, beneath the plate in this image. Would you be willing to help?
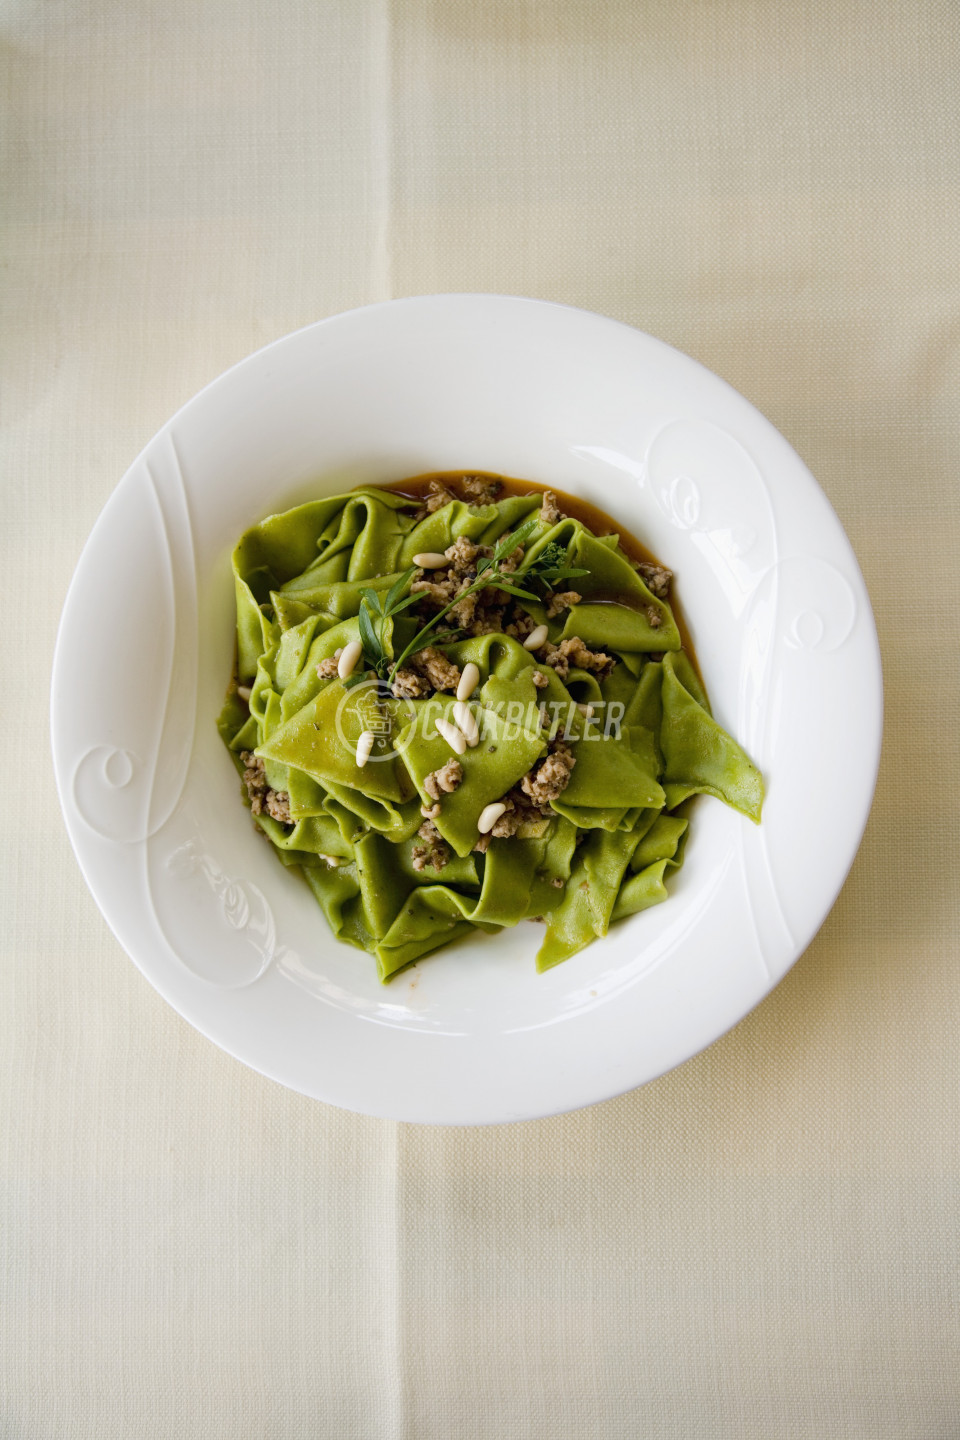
[0,0,960,1440]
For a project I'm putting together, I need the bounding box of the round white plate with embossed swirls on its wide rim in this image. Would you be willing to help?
[52,295,882,1125]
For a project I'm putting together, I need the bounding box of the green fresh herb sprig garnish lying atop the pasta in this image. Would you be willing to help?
[345,516,589,685]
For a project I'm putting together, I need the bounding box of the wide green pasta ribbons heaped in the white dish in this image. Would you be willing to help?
[219,490,763,981]
